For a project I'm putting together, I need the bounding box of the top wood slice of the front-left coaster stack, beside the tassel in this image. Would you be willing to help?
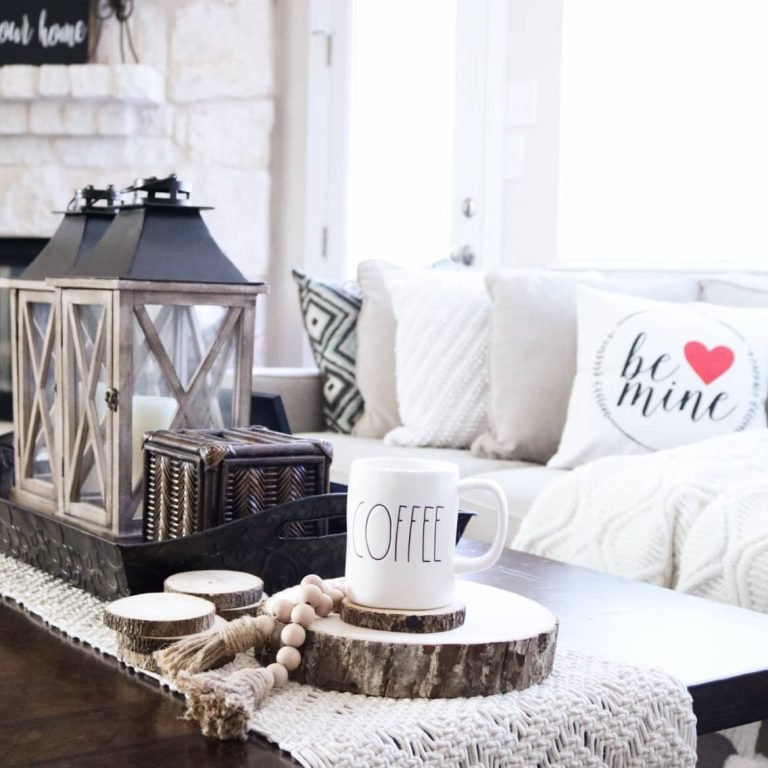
[104,592,216,637]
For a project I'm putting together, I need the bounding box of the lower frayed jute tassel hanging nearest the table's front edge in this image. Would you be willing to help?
[176,667,274,741]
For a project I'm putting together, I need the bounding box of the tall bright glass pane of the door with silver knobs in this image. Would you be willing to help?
[346,0,456,275]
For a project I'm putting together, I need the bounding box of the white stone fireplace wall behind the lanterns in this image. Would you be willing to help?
[0,0,275,280]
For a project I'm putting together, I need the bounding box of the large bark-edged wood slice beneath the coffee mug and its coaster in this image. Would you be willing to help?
[291,581,557,699]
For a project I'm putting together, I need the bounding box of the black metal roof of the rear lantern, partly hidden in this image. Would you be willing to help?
[21,185,121,280]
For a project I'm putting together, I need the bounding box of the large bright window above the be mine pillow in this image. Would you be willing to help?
[558,0,768,267]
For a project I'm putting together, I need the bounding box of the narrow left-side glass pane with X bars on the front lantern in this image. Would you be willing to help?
[71,304,111,507]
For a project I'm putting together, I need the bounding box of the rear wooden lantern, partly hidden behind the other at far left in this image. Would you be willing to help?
[7,187,119,513]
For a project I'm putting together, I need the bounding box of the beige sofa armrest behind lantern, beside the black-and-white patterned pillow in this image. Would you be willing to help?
[251,368,325,432]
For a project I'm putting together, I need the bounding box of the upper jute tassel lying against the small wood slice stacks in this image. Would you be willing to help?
[154,616,275,680]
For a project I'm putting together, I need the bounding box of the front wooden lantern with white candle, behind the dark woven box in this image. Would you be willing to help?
[48,176,267,538]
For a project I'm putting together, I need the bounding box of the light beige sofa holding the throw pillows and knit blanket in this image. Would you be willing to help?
[253,270,768,544]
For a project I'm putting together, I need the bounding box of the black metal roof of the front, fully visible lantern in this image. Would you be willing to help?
[68,175,248,283]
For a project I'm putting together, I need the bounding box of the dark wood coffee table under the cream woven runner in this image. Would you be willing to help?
[0,542,768,768]
